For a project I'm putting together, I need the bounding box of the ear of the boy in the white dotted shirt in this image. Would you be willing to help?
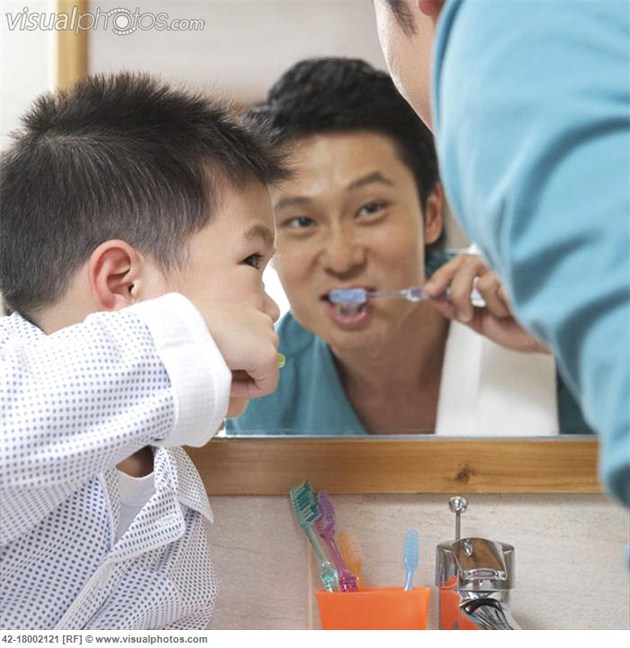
[88,240,144,311]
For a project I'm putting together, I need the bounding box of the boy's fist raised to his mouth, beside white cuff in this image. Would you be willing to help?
[193,299,280,399]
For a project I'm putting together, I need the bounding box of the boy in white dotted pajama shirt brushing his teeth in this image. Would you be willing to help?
[0,75,285,629]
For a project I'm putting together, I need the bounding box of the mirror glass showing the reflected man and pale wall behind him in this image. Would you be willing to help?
[64,0,590,437]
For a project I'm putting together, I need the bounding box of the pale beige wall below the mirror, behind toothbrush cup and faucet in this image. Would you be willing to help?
[210,495,630,630]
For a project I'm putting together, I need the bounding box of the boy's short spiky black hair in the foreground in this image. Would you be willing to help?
[0,73,288,316]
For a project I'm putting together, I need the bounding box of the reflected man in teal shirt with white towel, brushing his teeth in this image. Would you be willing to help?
[227,57,588,436]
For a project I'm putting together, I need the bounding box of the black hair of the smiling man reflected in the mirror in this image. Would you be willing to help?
[248,58,446,251]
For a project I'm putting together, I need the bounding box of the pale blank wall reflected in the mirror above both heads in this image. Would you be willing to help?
[90,0,385,102]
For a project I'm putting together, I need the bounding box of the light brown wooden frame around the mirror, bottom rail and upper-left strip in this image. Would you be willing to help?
[57,0,602,495]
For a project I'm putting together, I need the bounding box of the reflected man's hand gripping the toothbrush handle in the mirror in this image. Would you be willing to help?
[424,254,549,353]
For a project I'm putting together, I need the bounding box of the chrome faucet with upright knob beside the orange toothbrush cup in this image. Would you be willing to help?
[435,496,520,630]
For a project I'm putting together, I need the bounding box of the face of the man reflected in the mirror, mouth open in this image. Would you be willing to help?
[272,132,442,350]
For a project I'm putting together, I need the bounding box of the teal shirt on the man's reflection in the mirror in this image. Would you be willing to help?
[226,313,590,437]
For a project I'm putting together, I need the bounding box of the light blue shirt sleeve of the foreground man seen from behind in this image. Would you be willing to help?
[433,0,630,505]
